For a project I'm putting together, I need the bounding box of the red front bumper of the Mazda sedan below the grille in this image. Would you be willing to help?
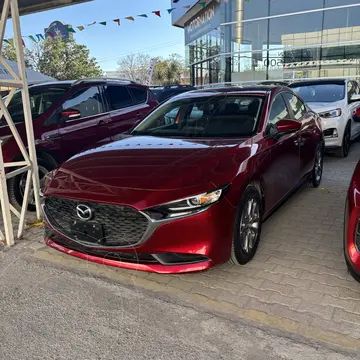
[45,198,235,274]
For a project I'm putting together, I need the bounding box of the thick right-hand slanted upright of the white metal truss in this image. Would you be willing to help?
[10,0,41,220]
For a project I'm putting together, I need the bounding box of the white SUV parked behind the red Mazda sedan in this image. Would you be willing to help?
[289,79,360,157]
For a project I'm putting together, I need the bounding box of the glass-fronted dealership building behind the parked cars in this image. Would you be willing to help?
[172,0,360,85]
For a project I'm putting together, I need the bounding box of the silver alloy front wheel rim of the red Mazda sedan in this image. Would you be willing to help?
[240,198,260,253]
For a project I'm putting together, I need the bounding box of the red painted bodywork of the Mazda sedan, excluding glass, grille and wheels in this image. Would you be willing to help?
[44,88,323,273]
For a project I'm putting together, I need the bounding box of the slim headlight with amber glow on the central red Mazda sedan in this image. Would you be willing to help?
[147,186,228,220]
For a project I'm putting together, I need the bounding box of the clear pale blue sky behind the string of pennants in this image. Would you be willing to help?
[5,0,185,71]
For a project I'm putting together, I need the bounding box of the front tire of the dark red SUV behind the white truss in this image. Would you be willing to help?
[8,158,54,211]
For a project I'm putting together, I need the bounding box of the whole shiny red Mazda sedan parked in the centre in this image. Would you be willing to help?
[42,86,324,273]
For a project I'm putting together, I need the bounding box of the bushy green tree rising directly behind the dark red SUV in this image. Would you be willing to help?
[30,38,102,80]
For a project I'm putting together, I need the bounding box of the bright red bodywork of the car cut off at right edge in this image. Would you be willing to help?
[344,161,360,274]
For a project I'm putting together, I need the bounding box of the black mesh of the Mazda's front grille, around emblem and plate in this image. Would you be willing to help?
[45,197,148,247]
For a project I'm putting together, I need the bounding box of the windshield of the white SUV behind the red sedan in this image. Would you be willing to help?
[291,83,345,102]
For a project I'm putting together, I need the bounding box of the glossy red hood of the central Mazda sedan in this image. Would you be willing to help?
[45,136,251,208]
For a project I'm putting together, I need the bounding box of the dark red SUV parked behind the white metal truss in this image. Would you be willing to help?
[0,79,157,210]
